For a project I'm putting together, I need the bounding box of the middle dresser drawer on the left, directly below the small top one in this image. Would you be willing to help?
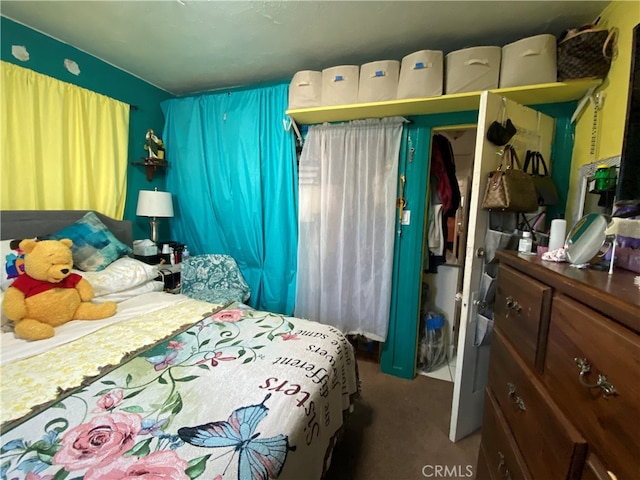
[483,330,587,479]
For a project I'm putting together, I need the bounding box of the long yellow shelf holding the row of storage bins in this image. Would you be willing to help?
[286,78,602,125]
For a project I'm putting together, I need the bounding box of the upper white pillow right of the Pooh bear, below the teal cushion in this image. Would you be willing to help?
[74,257,159,297]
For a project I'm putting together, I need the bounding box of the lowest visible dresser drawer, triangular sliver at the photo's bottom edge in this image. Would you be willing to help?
[476,390,532,480]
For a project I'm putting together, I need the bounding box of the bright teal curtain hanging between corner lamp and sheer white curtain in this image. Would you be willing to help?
[162,84,298,315]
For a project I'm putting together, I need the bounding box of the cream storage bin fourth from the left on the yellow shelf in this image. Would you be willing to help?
[397,50,444,98]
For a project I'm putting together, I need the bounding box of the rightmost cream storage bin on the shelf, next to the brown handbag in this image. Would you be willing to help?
[500,34,557,88]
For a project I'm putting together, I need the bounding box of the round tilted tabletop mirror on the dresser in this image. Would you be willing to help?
[565,213,609,264]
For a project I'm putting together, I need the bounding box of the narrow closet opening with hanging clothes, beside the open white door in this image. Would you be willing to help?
[416,125,477,383]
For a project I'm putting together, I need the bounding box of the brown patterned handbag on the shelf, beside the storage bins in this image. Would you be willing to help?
[556,25,617,82]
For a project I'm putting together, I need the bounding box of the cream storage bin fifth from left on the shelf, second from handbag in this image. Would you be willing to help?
[445,47,502,94]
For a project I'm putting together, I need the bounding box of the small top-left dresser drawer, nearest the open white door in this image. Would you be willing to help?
[494,264,551,370]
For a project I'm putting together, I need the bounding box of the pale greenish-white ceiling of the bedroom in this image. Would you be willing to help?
[0,0,609,95]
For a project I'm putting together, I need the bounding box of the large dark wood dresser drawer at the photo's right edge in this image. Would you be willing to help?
[542,294,640,479]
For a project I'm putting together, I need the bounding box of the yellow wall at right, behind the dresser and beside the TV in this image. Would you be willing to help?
[567,0,640,218]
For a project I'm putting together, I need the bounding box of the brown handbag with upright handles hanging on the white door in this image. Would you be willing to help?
[482,145,538,213]
